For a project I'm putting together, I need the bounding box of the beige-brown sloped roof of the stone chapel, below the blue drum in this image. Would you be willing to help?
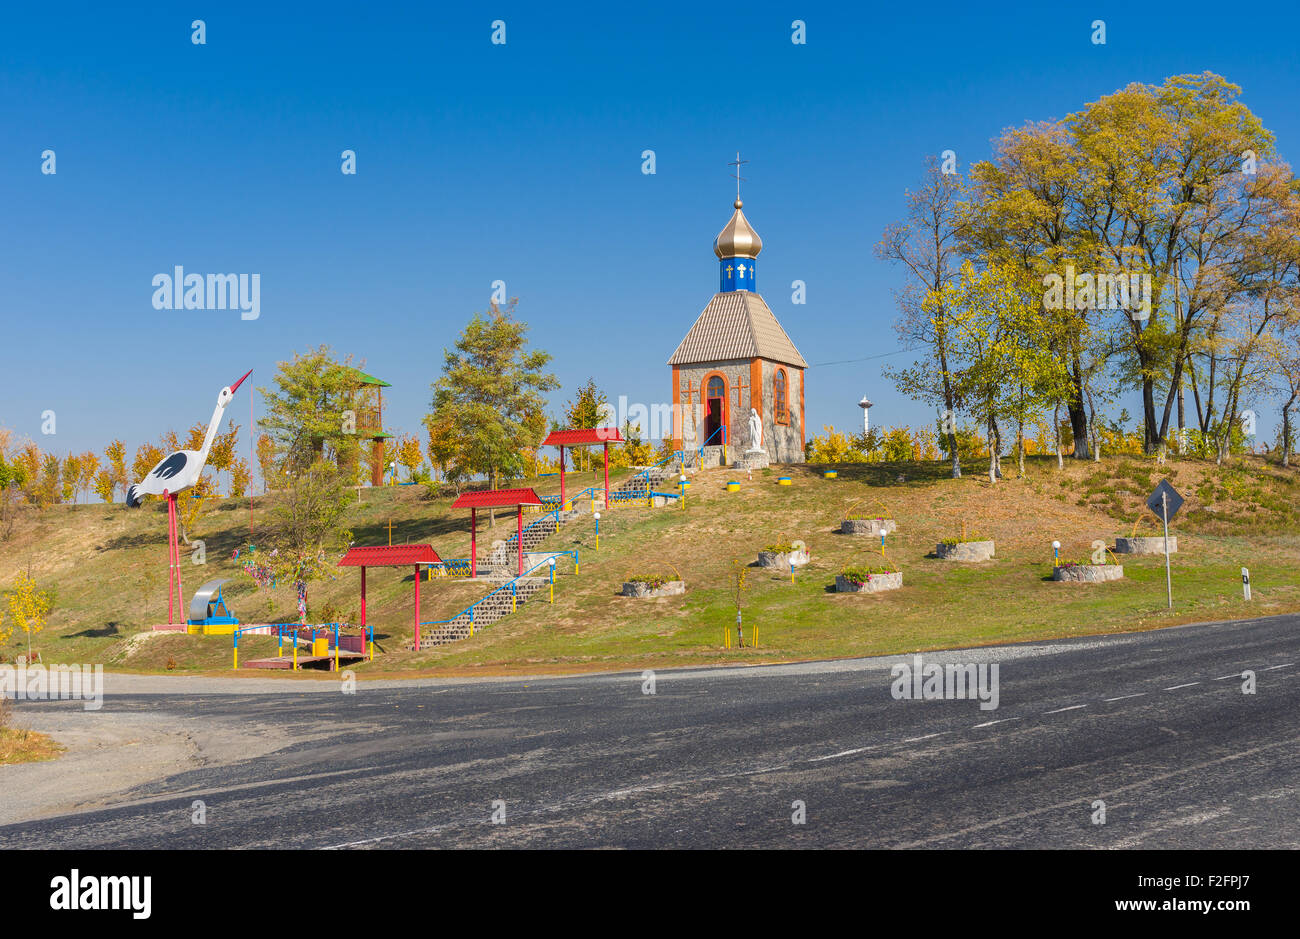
[668,290,807,368]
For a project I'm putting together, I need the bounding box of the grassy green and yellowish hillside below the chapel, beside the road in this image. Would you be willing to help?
[0,458,1300,675]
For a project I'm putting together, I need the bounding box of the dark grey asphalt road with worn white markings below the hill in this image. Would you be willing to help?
[0,616,1300,848]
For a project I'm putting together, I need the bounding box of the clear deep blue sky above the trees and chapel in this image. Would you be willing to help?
[0,0,1300,460]
